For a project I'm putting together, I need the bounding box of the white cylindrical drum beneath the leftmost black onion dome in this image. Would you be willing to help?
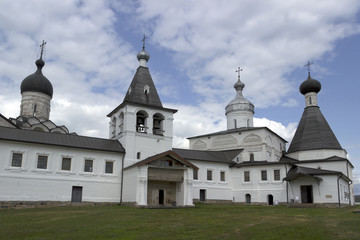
[20,92,51,120]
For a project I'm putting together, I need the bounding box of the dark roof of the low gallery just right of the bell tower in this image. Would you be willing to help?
[173,148,243,163]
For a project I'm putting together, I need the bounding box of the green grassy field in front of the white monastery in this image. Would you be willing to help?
[0,204,360,240]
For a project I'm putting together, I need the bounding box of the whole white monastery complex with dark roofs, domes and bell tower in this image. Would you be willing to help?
[0,41,354,206]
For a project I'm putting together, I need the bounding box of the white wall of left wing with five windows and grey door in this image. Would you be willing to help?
[0,141,122,202]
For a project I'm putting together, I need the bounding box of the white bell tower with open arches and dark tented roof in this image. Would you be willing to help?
[107,36,177,167]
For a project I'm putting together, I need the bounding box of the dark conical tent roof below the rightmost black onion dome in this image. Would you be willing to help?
[287,106,342,153]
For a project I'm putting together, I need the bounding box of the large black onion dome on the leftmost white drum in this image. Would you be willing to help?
[20,58,53,97]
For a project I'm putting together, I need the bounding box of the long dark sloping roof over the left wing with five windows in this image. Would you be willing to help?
[0,127,125,153]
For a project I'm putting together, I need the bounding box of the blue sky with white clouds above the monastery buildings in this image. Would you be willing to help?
[0,0,360,192]
